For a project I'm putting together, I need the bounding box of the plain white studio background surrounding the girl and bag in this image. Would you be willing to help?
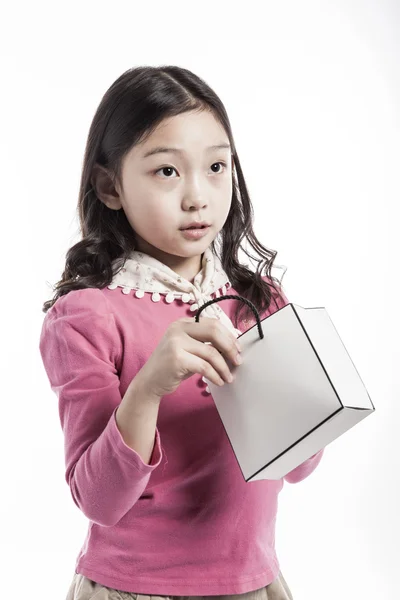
[0,0,400,600]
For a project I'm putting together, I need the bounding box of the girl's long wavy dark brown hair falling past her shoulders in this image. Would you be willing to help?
[42,65,288,327]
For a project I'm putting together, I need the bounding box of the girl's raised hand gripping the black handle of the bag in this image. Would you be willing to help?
[136,317,240,399]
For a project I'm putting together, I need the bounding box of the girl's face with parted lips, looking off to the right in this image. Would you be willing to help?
[115,111,232,281]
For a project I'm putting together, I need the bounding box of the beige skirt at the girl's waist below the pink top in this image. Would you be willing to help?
[66,572,293,600]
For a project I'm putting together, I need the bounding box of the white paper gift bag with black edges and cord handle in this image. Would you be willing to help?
[195,294,375,481]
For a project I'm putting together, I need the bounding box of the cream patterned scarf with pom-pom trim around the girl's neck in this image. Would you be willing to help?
[108,247,241,337]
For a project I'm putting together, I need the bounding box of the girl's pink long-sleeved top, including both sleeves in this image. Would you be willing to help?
[40,276,323,596]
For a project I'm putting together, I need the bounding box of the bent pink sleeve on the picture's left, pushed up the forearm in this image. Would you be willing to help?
[39,288,162,527]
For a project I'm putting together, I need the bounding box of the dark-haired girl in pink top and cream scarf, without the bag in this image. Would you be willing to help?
[40,66,322,600]
